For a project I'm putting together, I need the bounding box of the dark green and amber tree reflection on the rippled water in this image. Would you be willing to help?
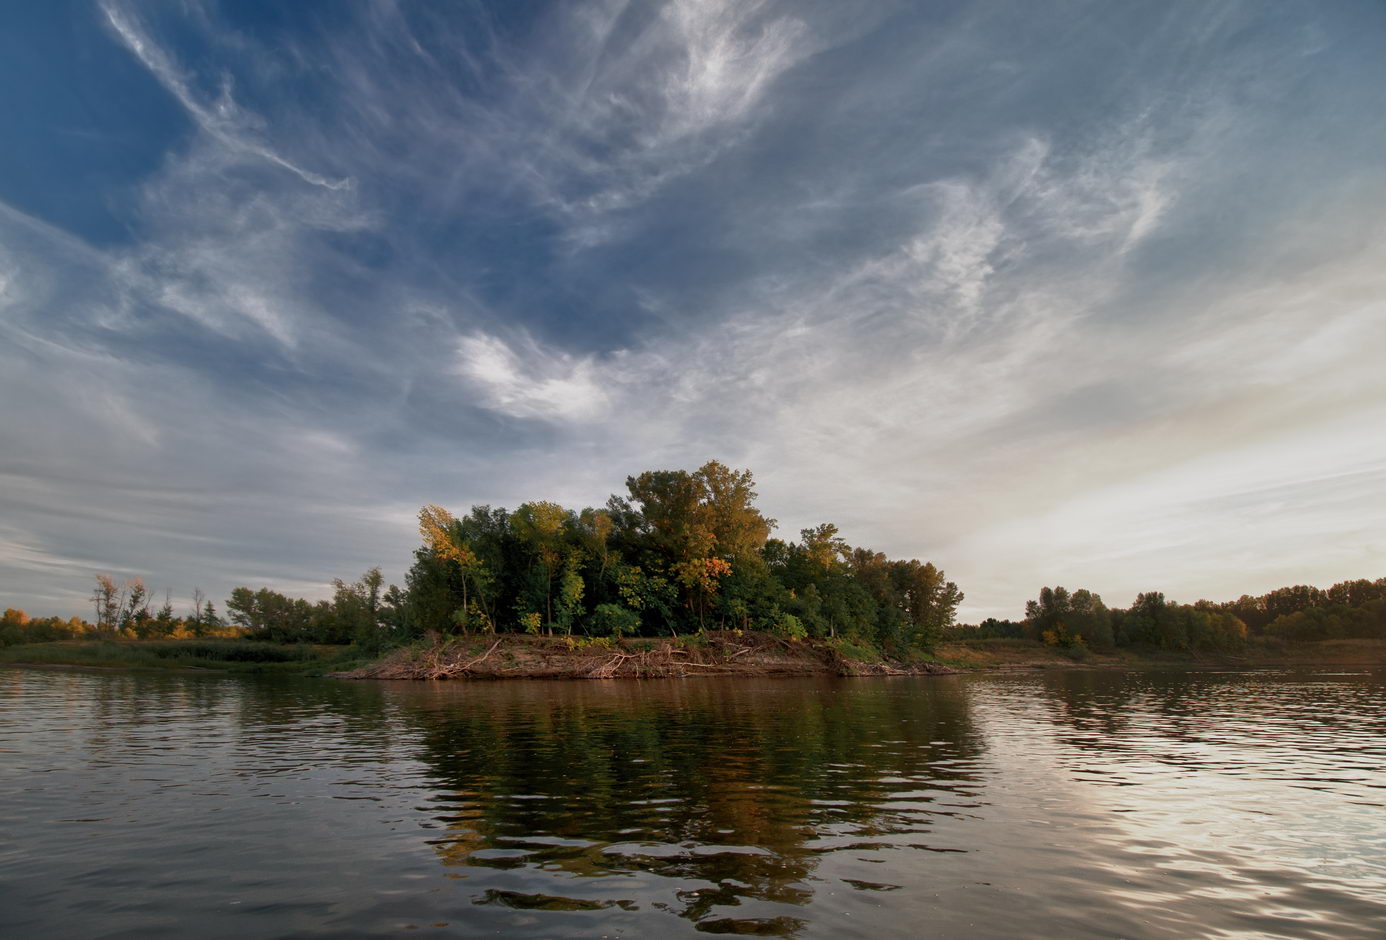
[392,679,979,934]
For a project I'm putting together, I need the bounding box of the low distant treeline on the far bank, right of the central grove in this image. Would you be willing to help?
[948,578,1386,650]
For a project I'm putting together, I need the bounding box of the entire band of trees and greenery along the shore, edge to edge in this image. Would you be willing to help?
[0,460,1386,674]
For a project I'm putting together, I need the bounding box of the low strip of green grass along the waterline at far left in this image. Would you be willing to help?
[0,639,367,675]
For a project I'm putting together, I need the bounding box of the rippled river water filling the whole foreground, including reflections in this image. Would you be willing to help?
[0,668,1386,937]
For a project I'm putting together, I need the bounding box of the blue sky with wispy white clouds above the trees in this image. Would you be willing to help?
[0,0,1386,621]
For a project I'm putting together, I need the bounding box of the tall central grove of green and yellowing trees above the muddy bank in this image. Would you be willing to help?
[385,460,962,650]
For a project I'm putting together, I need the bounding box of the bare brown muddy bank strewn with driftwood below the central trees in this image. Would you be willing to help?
[334,631,955,679]
